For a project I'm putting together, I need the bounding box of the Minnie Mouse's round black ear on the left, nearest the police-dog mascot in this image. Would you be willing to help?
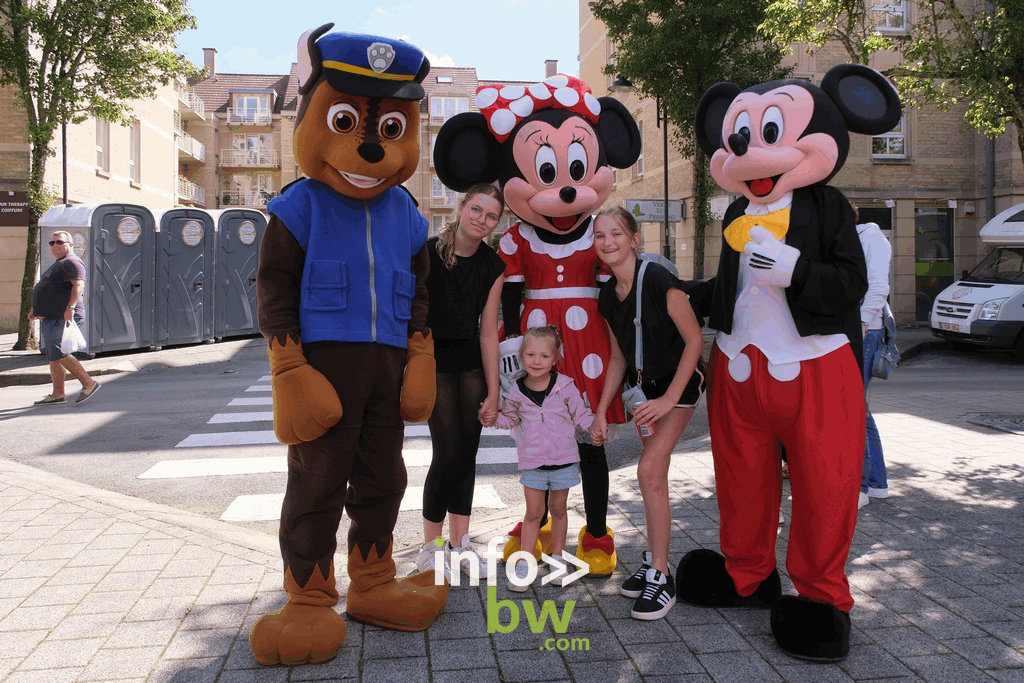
[434,112,502,193]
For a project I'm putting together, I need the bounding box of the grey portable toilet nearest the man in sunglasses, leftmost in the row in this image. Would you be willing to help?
[39,204,157,353]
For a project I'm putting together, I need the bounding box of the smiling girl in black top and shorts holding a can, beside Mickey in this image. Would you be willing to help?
[591,207,706,620]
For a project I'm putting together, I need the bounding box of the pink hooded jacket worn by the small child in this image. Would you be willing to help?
[495,375,594,470]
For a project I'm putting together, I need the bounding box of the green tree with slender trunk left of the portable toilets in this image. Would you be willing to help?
[0,0,197,349]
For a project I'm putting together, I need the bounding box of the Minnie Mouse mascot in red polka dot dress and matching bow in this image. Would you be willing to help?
[434,74,640,574]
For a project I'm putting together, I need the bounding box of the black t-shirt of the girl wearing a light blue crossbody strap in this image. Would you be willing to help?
[597,260,701,380]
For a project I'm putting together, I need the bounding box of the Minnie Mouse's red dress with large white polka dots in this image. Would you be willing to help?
[498,221,626,425]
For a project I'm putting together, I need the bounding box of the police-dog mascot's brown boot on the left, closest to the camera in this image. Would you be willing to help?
[249,562,345,667]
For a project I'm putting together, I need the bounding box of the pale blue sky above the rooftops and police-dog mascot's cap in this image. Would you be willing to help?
[172,0,586,81]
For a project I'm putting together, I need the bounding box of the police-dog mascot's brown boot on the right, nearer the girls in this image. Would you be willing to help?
[345,544,449,631]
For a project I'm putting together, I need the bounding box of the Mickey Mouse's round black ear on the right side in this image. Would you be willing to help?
[821,65,903,135]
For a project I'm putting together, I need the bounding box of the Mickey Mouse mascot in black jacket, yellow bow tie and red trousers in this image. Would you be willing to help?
[676,65,901,661]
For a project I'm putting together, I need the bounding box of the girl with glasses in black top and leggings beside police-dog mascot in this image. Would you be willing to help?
[418,184,505,577]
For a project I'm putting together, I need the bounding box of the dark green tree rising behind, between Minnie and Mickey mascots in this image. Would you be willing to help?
[590,0,788,278]
